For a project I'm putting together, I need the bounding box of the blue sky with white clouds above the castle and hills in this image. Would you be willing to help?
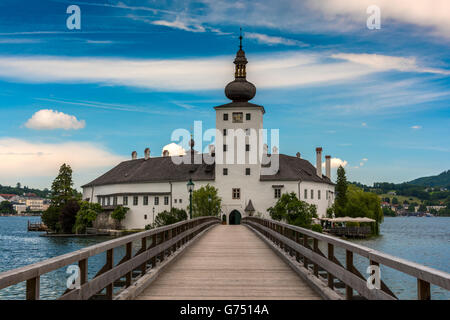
[0,0,450,188]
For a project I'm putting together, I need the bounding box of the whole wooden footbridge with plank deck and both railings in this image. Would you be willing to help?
[0,217,450,300]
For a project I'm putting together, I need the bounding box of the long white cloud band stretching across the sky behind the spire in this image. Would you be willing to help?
[0,51,447,91]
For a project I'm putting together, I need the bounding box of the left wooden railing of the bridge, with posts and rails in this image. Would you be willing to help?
[0,217,220,300]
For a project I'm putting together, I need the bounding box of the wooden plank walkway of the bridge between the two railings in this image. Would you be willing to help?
[138,225,320,300]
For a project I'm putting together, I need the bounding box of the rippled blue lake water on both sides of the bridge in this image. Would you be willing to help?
[0,217,450,300]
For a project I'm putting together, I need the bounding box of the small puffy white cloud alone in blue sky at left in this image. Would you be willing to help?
[25,109,86,130]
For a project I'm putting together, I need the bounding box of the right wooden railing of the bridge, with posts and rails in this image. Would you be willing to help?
[242,217,450,300]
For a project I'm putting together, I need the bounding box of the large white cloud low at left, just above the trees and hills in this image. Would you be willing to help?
[0,138,123,183]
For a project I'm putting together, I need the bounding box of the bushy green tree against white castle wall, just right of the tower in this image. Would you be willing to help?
[267,192,317,228]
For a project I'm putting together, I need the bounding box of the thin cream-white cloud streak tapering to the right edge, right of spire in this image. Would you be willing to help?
[331,53,450,75]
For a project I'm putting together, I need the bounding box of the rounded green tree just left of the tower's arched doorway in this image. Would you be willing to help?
[192,184,222,217]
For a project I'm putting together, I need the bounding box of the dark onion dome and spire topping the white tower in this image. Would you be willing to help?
[225,28,256,102]
